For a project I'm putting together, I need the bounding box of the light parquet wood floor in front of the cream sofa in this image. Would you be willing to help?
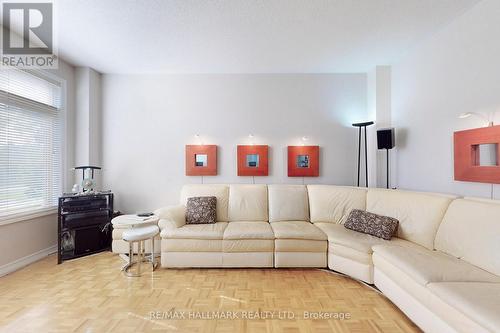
[0,253,419,333]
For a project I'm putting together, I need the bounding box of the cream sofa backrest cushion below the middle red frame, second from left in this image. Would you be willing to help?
[229,185,268,222]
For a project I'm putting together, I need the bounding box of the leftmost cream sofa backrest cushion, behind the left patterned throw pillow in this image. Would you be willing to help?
[181,184,229,222]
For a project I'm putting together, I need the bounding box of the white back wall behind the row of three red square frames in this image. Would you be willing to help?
[102,74,367,212]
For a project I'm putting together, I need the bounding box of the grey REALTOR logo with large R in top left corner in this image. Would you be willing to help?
[1,2,57,68]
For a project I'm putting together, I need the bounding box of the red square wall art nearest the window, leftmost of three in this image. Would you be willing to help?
[186,145,217,176]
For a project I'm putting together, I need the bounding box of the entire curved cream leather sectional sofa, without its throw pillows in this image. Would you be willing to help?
[113,185,500,332]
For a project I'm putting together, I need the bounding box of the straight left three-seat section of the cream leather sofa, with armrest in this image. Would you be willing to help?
[156,185,327,267]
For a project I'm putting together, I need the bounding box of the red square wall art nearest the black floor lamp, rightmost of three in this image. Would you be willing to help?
[288,146,319,177]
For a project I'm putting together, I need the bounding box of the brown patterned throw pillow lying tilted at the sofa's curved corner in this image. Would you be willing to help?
[344,209,399,240]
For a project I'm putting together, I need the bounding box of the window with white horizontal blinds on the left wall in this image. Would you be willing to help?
[0,69,63,219]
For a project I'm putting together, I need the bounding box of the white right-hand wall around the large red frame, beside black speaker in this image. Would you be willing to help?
[392,0,500,198]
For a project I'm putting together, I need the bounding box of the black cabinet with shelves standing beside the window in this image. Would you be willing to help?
[57,192,113,264]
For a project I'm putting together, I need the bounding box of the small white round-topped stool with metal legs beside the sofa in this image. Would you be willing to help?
[122,225,159,277]
